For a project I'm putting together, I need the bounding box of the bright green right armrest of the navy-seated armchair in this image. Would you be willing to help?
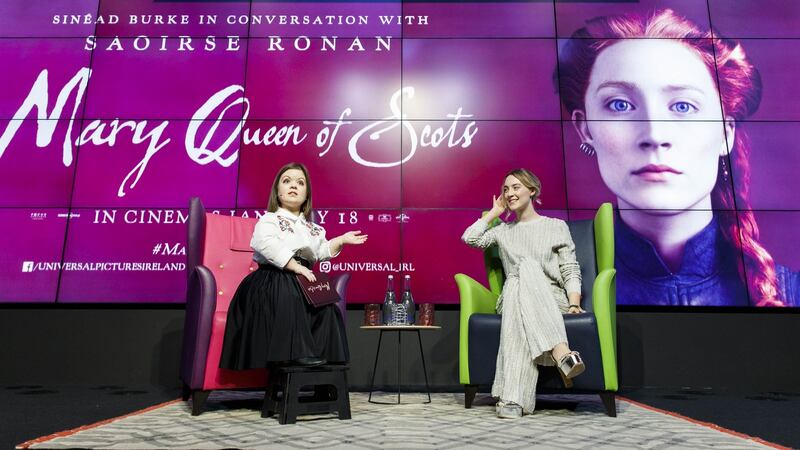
[592,269,619,391]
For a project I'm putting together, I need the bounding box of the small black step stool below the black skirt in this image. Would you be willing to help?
[261,365,350,425]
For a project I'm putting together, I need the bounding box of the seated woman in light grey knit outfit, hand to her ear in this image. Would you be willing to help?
[461,169,584,418]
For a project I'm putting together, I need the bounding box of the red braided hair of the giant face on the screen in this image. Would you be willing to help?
[557,9,784,306]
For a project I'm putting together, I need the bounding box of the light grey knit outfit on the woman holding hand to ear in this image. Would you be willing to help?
[461,216,581,412]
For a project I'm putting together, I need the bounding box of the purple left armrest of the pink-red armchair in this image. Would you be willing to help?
[180,265,217,389]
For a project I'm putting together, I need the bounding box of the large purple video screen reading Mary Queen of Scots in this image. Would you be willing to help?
[0,0,800,307]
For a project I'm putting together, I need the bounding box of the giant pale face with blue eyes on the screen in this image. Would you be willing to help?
[573,39,735,214]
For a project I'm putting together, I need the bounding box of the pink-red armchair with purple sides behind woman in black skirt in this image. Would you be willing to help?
[180,198,350,416]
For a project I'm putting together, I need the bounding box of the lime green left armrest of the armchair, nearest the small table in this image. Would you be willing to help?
[455,273,498,384]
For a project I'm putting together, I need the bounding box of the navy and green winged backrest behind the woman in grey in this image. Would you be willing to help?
[484,203,614,311]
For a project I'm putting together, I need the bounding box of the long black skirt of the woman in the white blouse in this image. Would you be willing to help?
[219,264,350,370]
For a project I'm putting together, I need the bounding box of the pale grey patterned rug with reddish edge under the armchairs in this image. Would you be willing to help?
[17,392,779,449]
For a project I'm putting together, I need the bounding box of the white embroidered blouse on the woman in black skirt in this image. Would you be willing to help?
[250,208,338,268]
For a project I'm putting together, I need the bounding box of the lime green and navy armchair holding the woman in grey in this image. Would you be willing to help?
[455,203,618,417]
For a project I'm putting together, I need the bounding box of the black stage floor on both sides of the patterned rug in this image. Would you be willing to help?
[0,385,800,448]
